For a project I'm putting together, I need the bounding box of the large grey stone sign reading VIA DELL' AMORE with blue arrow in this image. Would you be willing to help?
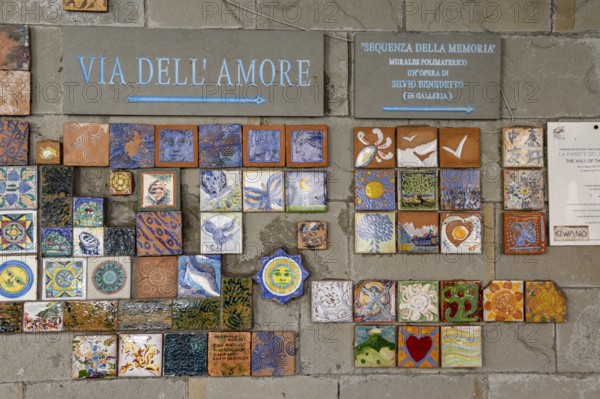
[63,27,324,116]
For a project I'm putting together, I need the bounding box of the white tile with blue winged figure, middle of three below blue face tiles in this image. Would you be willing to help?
[243,169,285,212]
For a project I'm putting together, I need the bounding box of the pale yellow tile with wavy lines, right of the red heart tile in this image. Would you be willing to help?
[440,326,483,368]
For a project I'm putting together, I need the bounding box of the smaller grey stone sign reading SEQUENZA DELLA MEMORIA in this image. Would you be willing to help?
[354,33,501,119]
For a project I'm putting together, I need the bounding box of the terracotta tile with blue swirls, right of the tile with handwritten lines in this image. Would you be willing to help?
[252,331,296,377]
